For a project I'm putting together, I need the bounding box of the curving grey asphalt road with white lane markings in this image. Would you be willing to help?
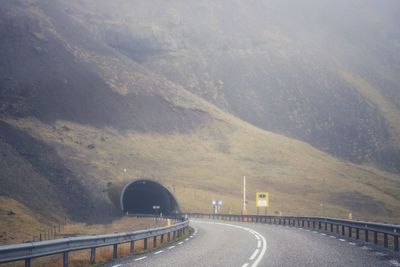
[105,220,400,267]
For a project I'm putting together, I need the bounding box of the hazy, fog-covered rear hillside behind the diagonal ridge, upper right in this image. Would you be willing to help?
[61,0,400,171]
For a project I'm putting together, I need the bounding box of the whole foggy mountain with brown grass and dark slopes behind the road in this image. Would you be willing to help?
[0,0,400,242]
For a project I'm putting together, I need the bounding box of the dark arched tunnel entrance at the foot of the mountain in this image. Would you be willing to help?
[121,179,180,215]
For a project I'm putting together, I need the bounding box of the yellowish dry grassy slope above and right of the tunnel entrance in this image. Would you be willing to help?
[3,111,400,222]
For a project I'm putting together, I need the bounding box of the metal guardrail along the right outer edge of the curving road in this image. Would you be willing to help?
[183,213,400,252]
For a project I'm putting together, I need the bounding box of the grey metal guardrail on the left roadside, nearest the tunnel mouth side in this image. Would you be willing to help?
[0,219,189,267]
